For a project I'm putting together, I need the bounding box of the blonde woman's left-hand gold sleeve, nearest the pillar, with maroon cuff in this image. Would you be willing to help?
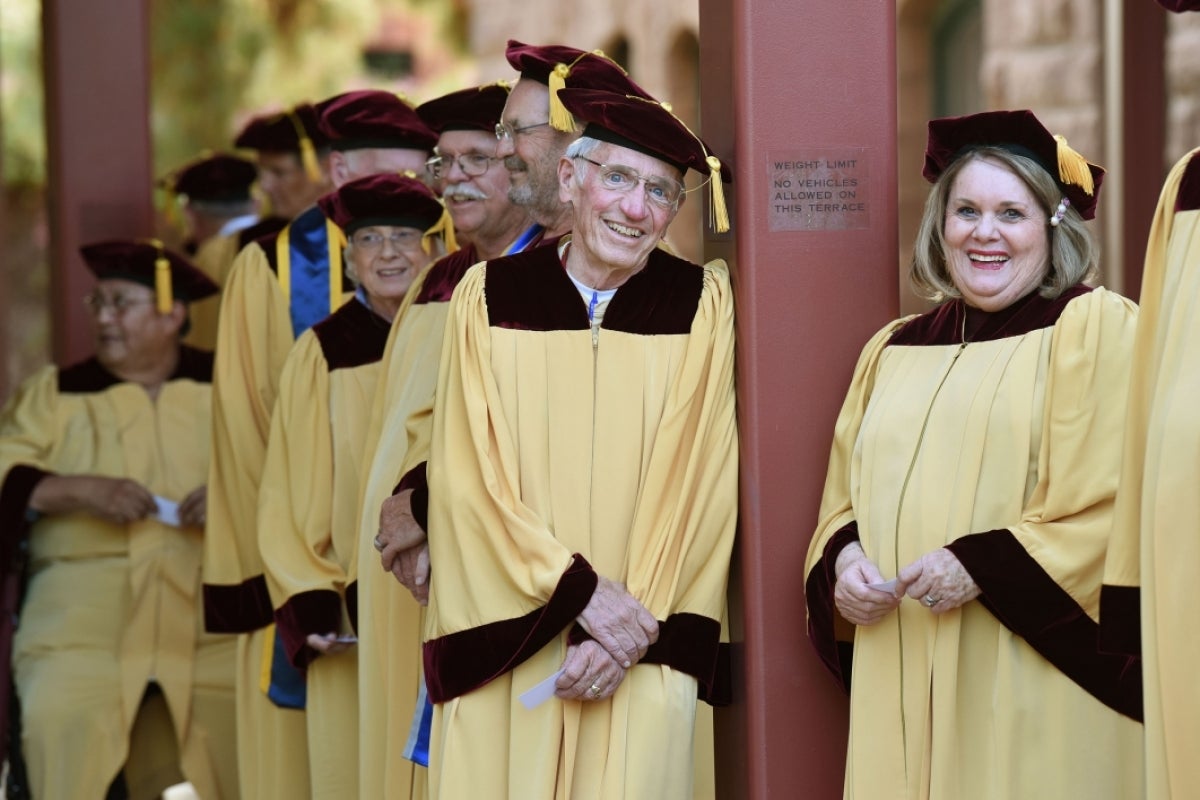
[804,318,911,690]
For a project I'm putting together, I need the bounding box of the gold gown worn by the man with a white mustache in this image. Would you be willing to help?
[355,246,475,800]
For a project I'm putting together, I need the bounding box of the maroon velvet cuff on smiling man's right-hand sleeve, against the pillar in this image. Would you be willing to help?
[566,612,732,705]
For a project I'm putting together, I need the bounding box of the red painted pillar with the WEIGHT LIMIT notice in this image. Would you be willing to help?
[700,0,902,800]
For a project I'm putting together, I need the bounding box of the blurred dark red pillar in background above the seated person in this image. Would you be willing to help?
[42,0,154,363]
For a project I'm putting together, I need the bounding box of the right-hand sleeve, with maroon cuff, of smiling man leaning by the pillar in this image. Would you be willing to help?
[626,261,738,704]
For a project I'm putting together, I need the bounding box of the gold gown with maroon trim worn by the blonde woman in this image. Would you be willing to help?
[805,285,1142,800]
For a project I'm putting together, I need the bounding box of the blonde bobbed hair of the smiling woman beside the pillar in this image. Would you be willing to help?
[908,148,1100,302]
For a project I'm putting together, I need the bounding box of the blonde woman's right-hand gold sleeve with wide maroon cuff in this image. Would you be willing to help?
[947,289,1141,718]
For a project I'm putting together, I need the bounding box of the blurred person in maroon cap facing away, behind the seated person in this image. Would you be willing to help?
[160,149,288,350]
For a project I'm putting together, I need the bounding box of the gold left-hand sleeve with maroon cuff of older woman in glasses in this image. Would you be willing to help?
[258,330,347,668]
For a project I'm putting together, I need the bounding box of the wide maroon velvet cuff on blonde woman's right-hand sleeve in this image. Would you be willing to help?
[947,529,1142,721]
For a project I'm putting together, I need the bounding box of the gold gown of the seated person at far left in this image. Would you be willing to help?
[0,348,238,800]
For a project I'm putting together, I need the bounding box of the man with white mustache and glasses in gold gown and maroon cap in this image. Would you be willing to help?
[353,83,532,800]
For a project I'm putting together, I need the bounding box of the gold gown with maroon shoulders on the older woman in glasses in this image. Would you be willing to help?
[258,301,390,800]
